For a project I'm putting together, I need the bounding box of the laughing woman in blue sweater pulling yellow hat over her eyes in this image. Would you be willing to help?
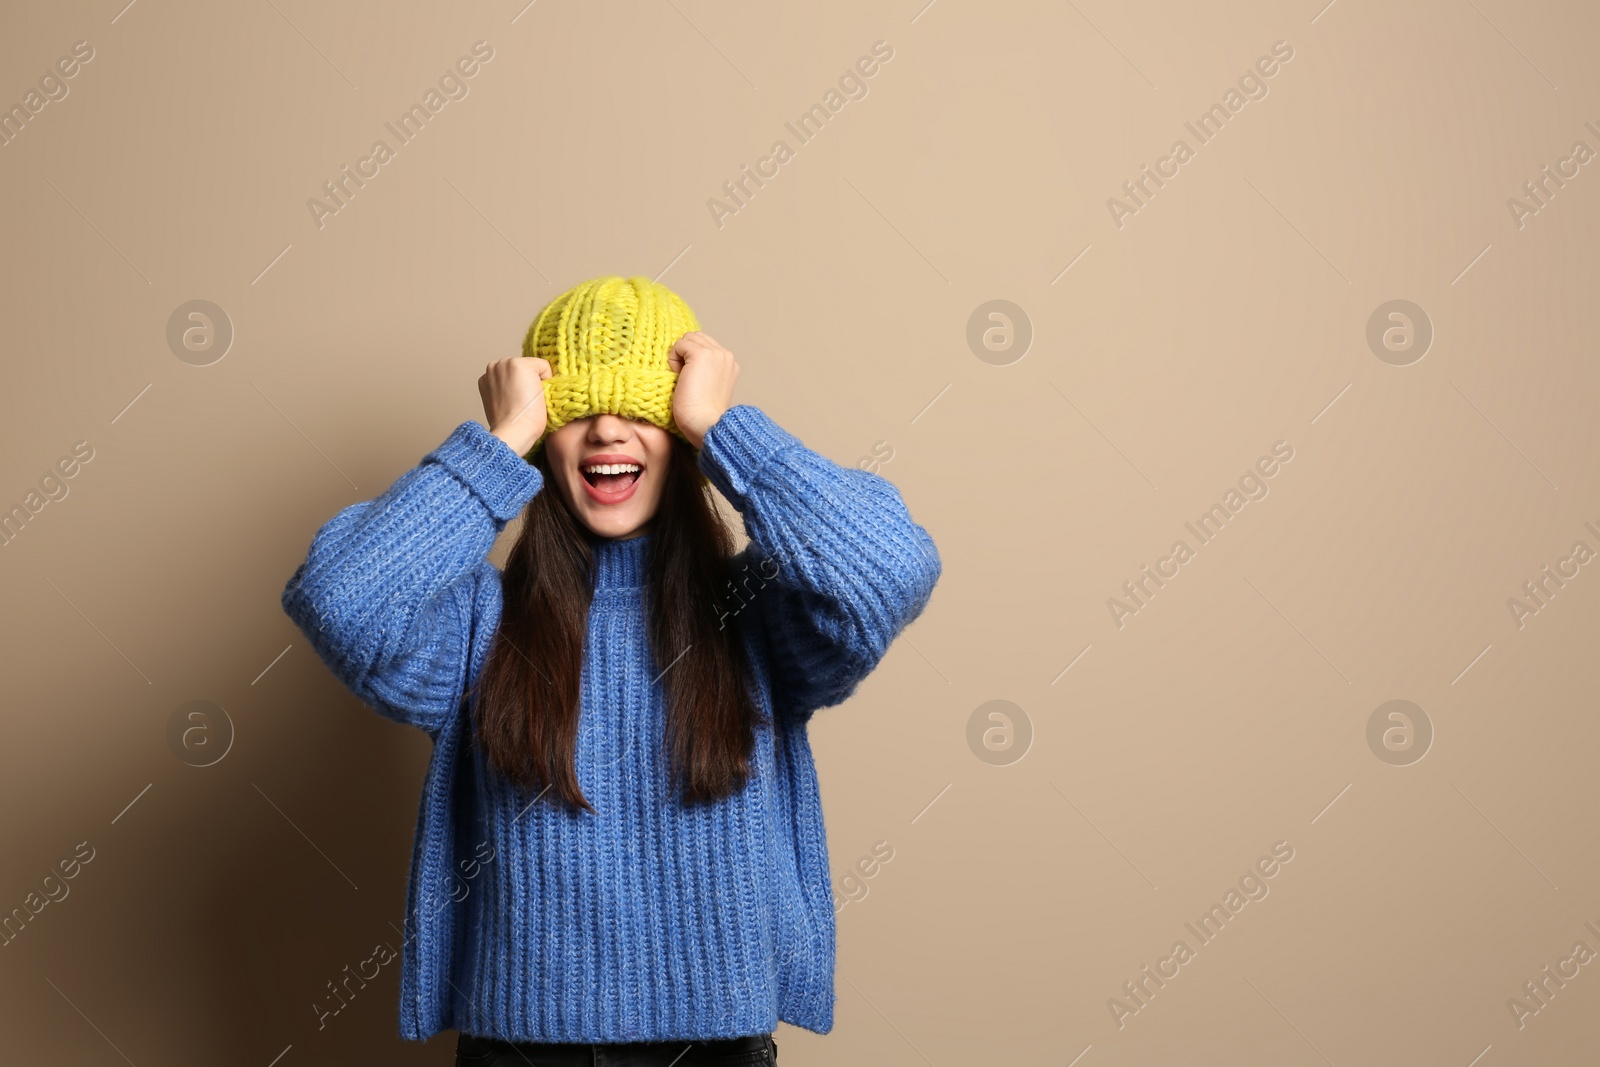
[283,277,941,1067]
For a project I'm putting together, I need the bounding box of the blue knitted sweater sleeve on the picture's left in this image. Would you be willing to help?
[283,421,542,737]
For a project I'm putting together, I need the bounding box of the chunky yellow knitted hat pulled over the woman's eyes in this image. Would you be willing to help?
[522,275,699,443]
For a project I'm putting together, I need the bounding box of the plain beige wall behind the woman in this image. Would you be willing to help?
[0,0,1600,1067]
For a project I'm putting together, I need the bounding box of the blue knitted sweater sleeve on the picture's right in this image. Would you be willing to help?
[699,405,941,718]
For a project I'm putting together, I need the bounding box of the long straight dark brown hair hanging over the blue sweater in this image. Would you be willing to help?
[474,435,770,811]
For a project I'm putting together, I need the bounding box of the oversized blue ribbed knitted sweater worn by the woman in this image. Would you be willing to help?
[283,405,941,1043]
